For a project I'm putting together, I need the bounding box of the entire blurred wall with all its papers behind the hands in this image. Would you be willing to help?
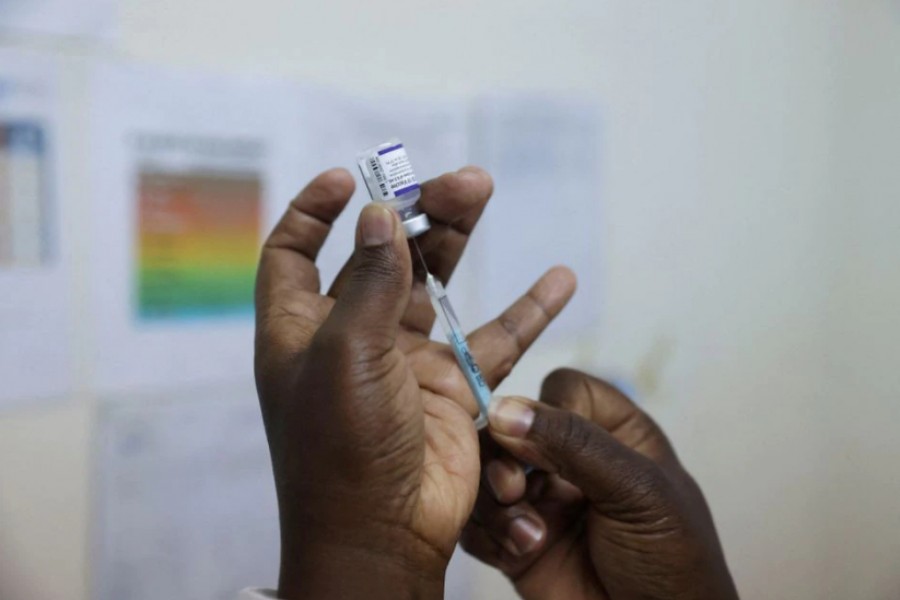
[0,0,900,600]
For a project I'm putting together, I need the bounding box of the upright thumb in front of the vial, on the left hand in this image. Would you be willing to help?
[323,203,412,352]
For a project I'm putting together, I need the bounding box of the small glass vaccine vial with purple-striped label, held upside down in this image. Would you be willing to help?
[356,138,431,238]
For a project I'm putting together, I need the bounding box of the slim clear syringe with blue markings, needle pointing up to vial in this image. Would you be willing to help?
[412,239,491,431]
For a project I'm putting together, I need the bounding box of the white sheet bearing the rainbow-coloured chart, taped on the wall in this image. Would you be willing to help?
[91,66,299,392]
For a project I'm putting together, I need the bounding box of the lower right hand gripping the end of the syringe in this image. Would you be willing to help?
[462,370,737,600]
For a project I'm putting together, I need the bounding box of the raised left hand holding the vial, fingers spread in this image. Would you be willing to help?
[256,168,574,600]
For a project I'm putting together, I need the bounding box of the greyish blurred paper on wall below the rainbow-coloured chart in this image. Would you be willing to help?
[93,386,279,600]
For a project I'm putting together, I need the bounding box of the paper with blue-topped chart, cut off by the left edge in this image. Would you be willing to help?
[0,51,72,405]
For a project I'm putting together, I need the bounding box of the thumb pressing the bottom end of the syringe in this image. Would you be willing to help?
[489,397,665,508]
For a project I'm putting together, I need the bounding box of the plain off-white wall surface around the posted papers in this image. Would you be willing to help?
[0,0,900,600]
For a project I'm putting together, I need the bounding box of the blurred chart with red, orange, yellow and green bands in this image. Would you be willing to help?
[133,135,263,322]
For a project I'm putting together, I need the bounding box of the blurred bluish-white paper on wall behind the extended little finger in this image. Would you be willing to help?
[471,95,602,341]
